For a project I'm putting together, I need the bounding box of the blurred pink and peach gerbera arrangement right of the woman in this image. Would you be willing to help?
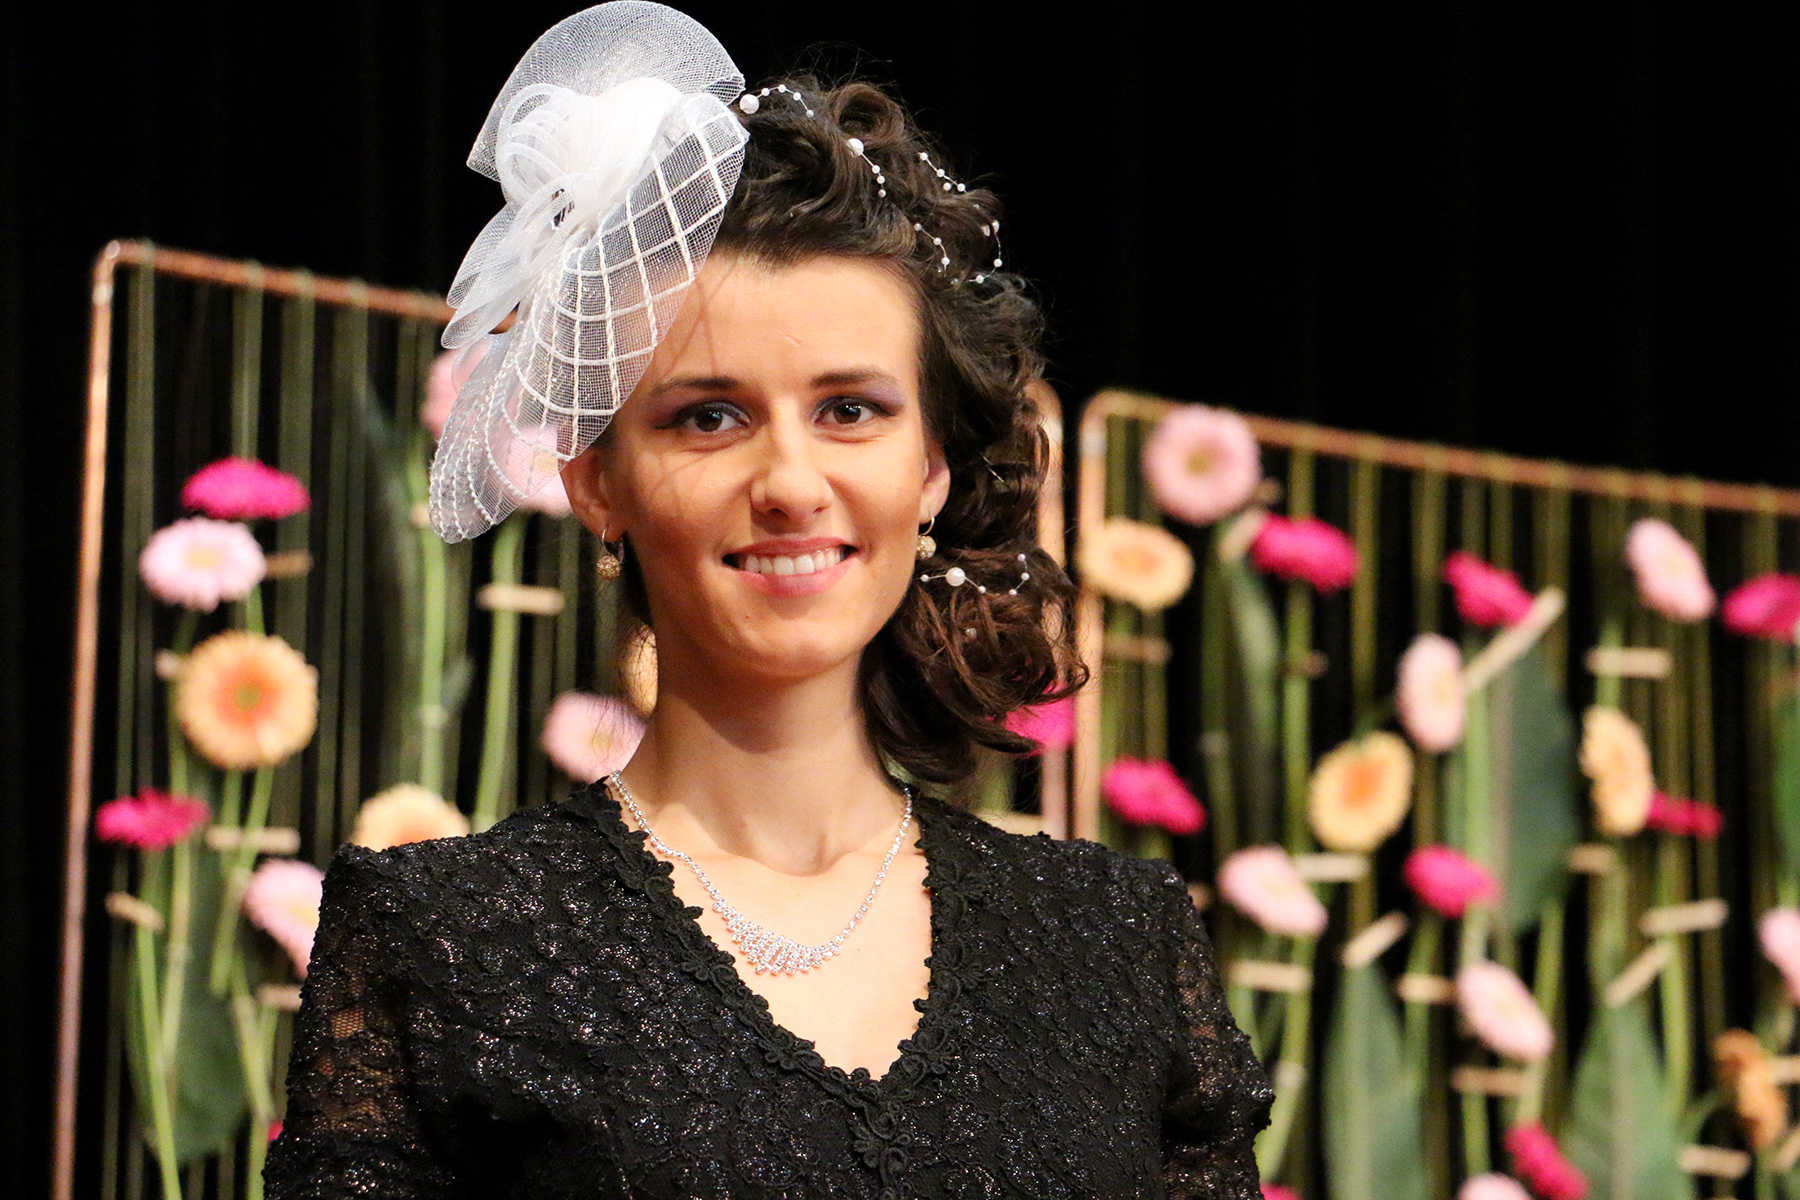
[1076,398,1800,1200]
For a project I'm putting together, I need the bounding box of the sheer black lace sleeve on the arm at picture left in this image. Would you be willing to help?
[263,844,463,1200]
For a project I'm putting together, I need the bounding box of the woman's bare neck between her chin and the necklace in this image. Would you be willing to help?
[625,636,905,874]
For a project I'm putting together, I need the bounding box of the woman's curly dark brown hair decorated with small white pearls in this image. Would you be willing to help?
[626,77,1087,783]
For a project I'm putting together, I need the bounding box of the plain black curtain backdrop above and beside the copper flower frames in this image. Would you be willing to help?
[0,0,1800,1196]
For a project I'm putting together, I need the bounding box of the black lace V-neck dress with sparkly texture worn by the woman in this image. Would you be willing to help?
[265,786,1273,1200]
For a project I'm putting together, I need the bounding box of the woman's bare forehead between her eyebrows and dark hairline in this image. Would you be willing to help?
[639,252,920,390]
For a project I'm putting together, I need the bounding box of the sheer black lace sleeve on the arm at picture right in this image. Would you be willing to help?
[1163,871,1274,1200]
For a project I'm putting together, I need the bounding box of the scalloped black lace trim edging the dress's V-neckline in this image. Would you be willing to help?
[571,779,956,1092]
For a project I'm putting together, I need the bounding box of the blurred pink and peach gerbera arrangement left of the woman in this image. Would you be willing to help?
[94,340,655,1200]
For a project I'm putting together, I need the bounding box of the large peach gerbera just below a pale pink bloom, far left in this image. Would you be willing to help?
[175,630,319,770]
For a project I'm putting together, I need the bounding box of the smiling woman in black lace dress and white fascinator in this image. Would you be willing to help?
[266,4,1271,1198]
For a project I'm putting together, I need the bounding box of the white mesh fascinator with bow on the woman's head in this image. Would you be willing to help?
[430,0,749,542]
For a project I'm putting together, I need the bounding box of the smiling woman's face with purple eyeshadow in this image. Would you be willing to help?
[563,252,949,678]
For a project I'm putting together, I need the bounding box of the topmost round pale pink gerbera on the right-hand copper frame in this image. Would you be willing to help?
[1143,405,1262,525]
